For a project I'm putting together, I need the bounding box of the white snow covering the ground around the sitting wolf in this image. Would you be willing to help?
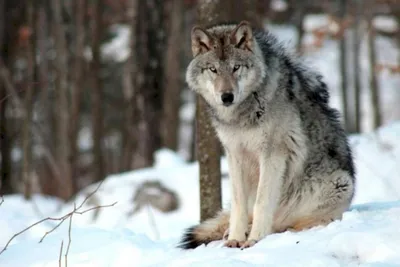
[0,122,400,267]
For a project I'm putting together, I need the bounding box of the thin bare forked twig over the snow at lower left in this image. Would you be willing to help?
[0,180,117,255]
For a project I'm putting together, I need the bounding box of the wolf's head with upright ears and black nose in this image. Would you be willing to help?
[186,21,266,107]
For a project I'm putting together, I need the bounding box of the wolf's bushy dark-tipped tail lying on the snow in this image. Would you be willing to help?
[178,211,229,249]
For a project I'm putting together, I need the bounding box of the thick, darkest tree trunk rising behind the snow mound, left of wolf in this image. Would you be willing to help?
[135,0,165,168]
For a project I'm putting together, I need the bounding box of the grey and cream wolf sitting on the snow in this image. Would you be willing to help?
[177,21,355,249]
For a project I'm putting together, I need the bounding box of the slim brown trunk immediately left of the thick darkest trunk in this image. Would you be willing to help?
[120,0,139,171]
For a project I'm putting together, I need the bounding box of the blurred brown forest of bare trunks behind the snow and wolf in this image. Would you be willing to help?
[0,0,400,219]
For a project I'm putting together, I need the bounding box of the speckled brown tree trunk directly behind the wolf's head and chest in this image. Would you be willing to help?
[196,0,262,221]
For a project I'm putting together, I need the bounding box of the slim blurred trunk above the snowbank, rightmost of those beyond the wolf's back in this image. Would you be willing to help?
[367,11,382,129]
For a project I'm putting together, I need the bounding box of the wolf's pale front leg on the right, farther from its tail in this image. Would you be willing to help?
[242,153,286,248]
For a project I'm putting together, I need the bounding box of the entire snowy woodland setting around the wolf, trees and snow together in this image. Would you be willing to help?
[0,0,400,267]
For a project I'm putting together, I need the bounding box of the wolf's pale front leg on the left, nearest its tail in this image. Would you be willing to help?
[225,151,248,247]
